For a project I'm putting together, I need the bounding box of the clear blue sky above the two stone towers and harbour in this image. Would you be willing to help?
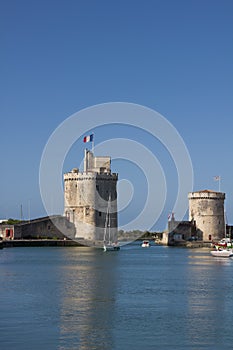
[0,0,233,229]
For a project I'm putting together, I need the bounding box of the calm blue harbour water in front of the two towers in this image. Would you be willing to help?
[0,242,233,350]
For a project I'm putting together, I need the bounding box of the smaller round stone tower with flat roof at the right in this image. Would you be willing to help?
[188,190,225,241]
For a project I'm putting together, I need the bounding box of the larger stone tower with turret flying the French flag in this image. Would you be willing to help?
[64,149,118,245]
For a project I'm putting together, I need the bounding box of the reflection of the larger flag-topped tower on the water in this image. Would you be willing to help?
[60,248,117,350]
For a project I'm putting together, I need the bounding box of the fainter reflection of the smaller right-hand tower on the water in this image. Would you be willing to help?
[187,251,232,346]
